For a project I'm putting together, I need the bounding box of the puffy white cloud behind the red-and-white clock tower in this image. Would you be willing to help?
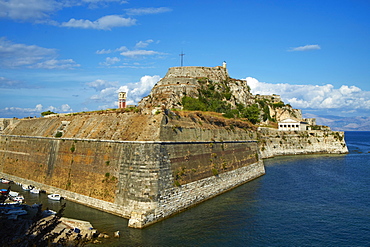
[89,75,161,109]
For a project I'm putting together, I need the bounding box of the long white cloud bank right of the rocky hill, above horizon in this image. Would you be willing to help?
[245,77,370,111]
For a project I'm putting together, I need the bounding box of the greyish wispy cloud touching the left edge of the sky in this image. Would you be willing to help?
[0,37,80,69]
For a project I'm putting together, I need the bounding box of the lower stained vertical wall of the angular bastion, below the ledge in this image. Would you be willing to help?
[0,135,264,227]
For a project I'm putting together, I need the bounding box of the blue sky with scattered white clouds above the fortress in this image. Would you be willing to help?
[0,0,370,123]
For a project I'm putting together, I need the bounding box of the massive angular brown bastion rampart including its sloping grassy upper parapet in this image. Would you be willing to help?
[0,114,264,228]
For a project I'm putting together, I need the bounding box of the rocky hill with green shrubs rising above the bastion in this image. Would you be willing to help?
[138,66,302,124]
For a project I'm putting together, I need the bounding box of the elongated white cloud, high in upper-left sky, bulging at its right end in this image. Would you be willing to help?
[60,15,136,30]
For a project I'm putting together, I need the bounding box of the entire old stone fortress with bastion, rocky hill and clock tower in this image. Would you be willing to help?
[0,63,348,228]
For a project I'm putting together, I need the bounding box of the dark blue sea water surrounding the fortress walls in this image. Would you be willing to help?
[2,131,370,246]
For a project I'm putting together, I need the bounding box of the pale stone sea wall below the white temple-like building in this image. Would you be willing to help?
[259,128,348,158]
